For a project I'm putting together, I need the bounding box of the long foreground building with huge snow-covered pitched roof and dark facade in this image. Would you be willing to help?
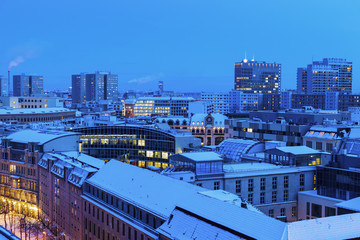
[82,160,286,240]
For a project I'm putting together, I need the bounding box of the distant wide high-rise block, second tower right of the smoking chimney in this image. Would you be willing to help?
[72,72,118,104]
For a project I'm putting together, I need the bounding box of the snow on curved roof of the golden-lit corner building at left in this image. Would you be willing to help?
[6,130,79,145]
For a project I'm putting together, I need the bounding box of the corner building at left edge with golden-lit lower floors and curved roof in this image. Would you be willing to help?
[0,130,78,217]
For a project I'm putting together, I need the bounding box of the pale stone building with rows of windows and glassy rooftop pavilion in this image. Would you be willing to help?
[164,152,315,221]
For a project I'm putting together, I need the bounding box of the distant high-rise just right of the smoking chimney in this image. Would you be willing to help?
[13,73,44,97]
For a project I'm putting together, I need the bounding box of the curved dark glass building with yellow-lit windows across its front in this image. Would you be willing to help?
[72,124,201,168]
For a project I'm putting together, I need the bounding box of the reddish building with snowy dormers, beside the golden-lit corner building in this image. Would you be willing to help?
[38,151,105,240]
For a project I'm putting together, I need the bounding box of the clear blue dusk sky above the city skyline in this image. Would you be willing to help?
[0,0,360,92]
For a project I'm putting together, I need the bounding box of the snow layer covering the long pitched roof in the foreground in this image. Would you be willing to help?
[87,160,286,240]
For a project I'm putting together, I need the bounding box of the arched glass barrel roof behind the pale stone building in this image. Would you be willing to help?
[216,138,261,162]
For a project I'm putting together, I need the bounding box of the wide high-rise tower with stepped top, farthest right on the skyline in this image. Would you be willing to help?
[297,58,352,94]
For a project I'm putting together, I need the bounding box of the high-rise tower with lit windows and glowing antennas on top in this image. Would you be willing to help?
[235,58,281,93]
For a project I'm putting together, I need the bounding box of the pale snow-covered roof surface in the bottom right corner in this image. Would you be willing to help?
[288,213,360,240]
